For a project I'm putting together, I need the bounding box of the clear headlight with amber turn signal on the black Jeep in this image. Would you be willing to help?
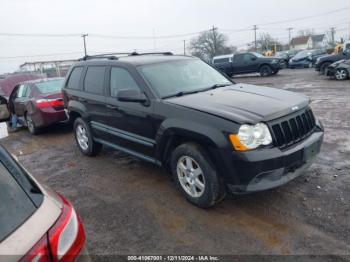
[230,123,272,151]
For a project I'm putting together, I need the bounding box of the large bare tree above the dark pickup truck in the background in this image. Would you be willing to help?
[190,28,237,61]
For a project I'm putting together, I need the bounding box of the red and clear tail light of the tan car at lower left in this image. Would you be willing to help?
[22,196,85,262]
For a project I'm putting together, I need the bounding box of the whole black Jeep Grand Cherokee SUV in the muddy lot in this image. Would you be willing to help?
[63,53,323,207]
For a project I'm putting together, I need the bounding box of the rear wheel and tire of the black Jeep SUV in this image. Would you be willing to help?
[74,117,102,156]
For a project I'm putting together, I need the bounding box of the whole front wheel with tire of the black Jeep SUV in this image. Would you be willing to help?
[171,143,226,208]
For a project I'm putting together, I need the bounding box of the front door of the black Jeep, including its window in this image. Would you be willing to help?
[102,67,155,157]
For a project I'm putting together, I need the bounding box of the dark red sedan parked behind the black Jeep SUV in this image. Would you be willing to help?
[0,78,67,135]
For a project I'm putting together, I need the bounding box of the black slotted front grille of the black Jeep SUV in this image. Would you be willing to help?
[270,108,316,149]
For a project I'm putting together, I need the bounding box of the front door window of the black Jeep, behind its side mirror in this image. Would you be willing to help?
[110,67,140,97]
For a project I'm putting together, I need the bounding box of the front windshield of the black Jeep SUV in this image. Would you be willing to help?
[140,59,232,98]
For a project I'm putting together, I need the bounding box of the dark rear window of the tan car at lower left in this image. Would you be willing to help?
[0,162,36,242]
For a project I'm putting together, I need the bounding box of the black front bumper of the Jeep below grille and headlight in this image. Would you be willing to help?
[218,125,323,194]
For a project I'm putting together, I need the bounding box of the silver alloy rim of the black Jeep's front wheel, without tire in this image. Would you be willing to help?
[176,156,205,198]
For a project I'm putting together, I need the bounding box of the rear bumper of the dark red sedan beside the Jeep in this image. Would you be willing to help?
[31,109,68,127]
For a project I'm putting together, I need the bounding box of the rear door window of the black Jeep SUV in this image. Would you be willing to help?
[84,66,106,95]
